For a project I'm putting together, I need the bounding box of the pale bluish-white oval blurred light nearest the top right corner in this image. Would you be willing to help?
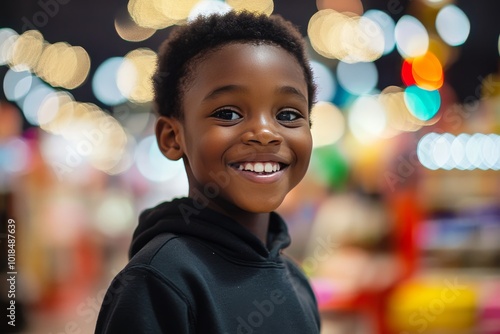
[436,5,470,46]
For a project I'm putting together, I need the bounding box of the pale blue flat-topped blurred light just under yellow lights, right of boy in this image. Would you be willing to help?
[337,62,378,95]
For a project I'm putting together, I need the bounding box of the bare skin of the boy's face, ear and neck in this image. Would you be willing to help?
[156,43,312,244]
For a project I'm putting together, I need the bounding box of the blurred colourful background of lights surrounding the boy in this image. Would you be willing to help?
[0,0,500,334]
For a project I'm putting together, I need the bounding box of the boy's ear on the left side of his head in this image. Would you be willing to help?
[155,116,184,160]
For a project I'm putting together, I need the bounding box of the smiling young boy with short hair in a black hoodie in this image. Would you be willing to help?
[96,12,320,334]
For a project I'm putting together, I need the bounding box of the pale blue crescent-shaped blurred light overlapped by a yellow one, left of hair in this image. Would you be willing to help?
[92,57,127,106]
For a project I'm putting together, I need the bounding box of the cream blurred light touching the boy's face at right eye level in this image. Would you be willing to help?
[311,102,345,147]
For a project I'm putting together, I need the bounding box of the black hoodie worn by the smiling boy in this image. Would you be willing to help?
[95,198,320,334]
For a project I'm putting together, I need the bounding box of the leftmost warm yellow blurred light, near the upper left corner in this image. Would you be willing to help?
[9,30,44,71]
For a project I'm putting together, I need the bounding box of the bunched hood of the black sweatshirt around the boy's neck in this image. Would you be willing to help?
[129,198,290,262]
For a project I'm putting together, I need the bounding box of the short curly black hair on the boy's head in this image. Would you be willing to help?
[153,11,316,119]
